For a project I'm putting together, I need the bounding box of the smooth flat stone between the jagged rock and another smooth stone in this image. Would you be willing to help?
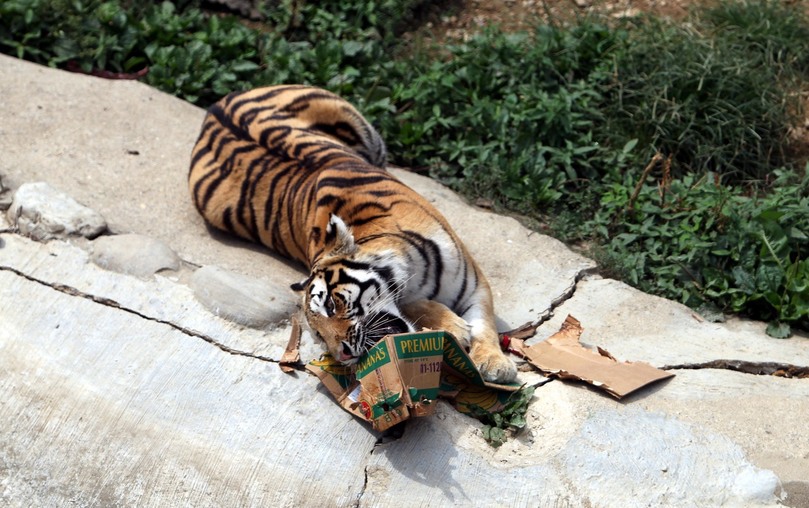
[91,234,180,277]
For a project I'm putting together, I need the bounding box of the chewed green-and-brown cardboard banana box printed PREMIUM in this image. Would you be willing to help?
[306,331,520,431]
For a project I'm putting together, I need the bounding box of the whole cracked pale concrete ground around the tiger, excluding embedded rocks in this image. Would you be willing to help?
[0,56,809,506]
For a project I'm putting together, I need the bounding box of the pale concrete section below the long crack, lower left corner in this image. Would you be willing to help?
[0,271,376,506]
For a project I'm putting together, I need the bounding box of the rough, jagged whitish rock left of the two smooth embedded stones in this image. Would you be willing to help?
[6,182,107,242]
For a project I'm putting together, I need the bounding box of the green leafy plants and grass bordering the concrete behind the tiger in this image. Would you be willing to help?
[0,0,809,336]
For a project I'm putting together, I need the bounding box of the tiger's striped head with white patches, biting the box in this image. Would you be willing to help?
[292,214,414,365]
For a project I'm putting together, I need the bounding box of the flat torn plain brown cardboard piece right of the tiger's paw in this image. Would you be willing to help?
[512,316,674,399]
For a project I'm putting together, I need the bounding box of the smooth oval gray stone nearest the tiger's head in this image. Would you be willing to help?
[190,266,297,328]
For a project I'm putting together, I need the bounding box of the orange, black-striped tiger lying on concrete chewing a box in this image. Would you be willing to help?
[188,85,517,383]
